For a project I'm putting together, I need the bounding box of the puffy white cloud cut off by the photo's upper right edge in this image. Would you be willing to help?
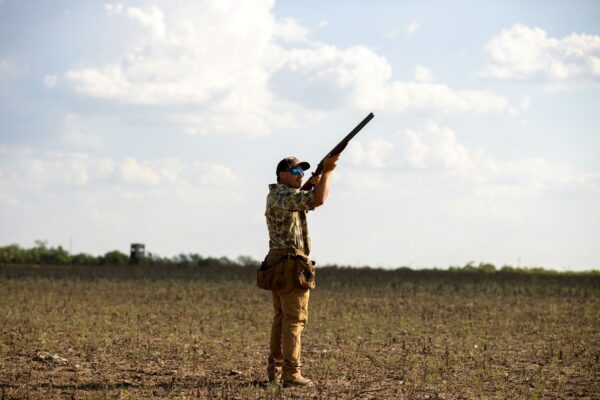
[481,24,600,82]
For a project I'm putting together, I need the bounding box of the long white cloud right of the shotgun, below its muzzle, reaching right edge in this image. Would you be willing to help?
[345,123,600,198]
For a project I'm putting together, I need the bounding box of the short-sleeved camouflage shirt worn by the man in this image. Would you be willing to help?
[265,183,315,255]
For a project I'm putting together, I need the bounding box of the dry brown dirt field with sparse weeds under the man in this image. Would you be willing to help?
[0,266,600,399]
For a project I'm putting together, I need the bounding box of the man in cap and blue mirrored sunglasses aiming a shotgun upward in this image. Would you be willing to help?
[265,155,339,387]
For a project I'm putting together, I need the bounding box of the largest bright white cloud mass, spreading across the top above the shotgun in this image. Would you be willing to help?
[64,0,514,136]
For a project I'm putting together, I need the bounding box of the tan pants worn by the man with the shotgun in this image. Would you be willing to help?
[266,252,310,381]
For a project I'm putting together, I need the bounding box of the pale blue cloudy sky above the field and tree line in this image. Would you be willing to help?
[0,0,600,270]
